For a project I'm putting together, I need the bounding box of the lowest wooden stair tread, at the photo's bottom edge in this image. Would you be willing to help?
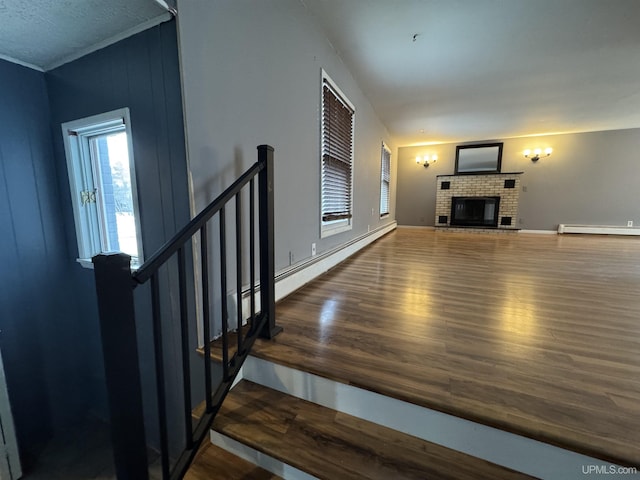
[184,441,282,480]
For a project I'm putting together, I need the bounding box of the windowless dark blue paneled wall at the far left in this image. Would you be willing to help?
[0,60,93,465]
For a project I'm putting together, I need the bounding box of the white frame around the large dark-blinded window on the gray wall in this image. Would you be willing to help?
[319,69,356,238]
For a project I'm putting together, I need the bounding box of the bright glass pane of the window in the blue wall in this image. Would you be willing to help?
[92,131,138,258]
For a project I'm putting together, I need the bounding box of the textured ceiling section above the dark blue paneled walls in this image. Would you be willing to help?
[0,0,169,70]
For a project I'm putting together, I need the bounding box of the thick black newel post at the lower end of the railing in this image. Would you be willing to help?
[93,253,149,480]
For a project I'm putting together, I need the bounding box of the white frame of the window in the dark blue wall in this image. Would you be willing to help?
[61,107,144,268]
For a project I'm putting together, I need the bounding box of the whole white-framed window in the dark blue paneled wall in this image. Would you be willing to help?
[61,108,143,268]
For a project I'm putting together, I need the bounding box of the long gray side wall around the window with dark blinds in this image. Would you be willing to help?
[178,0,397,270]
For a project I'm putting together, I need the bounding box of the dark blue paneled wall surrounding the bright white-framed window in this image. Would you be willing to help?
[46,21,190,450]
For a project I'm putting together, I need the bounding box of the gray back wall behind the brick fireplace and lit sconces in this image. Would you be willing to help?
[397,129,640,230]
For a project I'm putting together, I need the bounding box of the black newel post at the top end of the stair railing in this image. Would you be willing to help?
[258,145,282,339]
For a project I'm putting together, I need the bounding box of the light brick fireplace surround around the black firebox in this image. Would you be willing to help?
[435,172,522,231]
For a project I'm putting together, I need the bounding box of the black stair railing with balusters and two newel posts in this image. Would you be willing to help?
[93,145,281,480]
